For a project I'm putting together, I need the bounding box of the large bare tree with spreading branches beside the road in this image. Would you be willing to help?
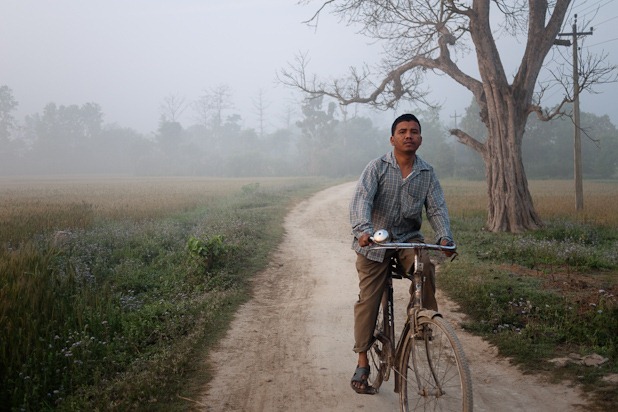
[279,0,616,232]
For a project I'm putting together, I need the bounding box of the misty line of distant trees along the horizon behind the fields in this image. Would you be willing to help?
[0,86,618,179]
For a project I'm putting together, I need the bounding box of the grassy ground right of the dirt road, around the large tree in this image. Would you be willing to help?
[439,181,618,410]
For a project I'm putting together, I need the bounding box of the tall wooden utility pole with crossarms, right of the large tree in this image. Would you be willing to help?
[554,14,592,210]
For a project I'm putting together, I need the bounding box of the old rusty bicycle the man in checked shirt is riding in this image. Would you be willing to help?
[367,230,473,412]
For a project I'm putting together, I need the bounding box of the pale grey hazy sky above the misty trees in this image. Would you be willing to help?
[0,0,618,133]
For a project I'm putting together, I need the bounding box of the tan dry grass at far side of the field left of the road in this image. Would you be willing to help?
[0,176,310,245]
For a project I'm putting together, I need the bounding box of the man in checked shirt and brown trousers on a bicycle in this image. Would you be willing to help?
[350,114,453,394]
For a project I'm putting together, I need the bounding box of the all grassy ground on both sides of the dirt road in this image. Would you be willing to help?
[0,178,618,411]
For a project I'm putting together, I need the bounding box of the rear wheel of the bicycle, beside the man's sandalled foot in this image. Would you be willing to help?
[367,290,390,392]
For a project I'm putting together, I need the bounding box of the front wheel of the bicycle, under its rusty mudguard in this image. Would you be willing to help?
[399,317,472,412]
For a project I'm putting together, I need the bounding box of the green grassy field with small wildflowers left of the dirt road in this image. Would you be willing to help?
[0,178,332,411]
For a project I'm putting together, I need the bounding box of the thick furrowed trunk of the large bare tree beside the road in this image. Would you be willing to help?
[470,0,544,232]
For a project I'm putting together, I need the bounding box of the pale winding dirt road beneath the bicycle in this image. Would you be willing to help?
[197,183,584,412]
